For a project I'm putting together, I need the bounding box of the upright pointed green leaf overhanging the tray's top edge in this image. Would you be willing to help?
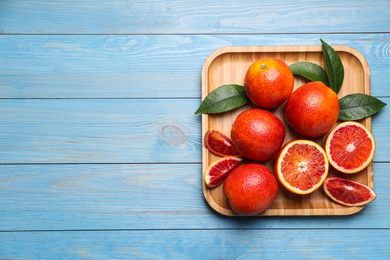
[320,39,344,93]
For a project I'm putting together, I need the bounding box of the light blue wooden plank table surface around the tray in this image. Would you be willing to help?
[0,0,390,259]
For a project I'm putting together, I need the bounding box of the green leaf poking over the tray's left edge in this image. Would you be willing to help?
[195,84,248,114]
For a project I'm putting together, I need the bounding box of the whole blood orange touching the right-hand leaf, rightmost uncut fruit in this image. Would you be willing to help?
[284,82,340,138]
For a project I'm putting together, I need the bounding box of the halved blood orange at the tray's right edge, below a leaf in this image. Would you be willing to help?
[325,121,375,174]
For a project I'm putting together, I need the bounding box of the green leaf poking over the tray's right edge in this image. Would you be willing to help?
[339,93,387,121]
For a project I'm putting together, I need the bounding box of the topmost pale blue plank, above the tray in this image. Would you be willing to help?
[0,0,390,34]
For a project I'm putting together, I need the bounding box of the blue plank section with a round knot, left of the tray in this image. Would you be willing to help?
[0,99,201,163]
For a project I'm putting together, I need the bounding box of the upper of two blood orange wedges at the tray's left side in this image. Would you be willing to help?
[204,128,240,156]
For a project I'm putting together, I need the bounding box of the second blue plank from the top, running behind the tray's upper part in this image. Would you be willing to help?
[0,34,390,98]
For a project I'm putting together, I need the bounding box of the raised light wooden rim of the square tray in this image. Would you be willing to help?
[201,45,374,217]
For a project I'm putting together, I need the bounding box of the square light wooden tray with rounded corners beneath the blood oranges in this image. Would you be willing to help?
[202,46,374,216]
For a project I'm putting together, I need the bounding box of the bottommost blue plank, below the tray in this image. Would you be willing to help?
[0,229,390,260]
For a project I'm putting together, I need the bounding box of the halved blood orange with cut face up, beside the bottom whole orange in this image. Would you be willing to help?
[274,140,329,194]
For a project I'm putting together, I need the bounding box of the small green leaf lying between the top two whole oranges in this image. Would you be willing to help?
[290,61,329,86]
